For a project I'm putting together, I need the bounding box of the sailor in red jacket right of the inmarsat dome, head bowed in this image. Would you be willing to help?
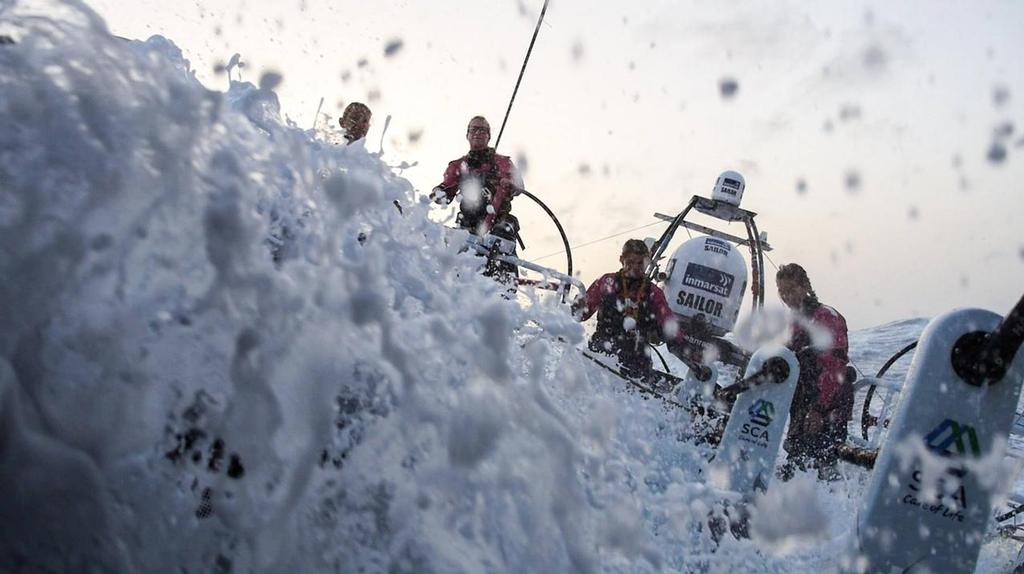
[775,263,853,479]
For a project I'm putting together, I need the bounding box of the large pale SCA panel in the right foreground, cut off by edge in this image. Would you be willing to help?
[850,309,1024,573]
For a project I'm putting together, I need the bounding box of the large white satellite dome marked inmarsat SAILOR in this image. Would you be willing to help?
[665,236,746,334]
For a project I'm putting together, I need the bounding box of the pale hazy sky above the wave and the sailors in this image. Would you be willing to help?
[89,0,1024,327]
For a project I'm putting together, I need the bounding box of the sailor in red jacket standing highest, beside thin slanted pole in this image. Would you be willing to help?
[433,116,523,239]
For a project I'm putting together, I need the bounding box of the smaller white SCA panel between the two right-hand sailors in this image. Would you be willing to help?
[711,346,800,497]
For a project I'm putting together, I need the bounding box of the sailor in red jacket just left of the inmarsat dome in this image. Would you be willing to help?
[573,239,683,379]
